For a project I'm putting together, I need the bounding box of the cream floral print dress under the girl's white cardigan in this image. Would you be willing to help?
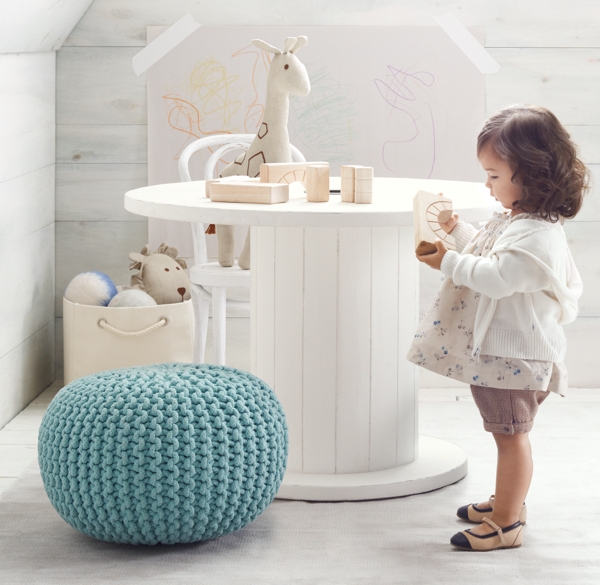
[406,212,567,396]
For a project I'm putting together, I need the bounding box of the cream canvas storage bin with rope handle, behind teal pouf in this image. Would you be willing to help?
[63,297,194,385]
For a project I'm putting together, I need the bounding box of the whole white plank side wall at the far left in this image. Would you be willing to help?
[0,53,56,428]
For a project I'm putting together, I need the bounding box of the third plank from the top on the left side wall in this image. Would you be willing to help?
[0,165,54,253]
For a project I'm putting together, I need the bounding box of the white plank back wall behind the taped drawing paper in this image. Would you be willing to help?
[56,0,600,386]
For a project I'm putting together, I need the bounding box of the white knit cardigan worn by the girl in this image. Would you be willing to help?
[441,215,583,362]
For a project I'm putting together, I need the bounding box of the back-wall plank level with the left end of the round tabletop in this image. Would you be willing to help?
[56,164,148,223]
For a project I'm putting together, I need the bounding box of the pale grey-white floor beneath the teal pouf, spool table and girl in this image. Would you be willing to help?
[0,397,600,585]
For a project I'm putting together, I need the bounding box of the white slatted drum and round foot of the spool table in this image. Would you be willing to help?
[251,226,467,501]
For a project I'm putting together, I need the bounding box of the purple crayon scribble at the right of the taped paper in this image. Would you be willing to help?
[374,57,446,178]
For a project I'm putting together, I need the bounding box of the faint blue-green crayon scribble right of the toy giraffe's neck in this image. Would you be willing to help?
[289,64,358,166]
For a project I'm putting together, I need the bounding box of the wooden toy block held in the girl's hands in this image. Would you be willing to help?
[413,191,456,254]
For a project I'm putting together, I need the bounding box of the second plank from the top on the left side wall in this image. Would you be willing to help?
[0,124,55,183]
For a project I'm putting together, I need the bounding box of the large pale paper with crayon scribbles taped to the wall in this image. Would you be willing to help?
[148,26,485,257]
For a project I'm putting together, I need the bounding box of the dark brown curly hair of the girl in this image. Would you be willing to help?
[477,104,589,223]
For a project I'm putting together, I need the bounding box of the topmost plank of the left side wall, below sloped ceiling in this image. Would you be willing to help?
[0,52,56,138]
